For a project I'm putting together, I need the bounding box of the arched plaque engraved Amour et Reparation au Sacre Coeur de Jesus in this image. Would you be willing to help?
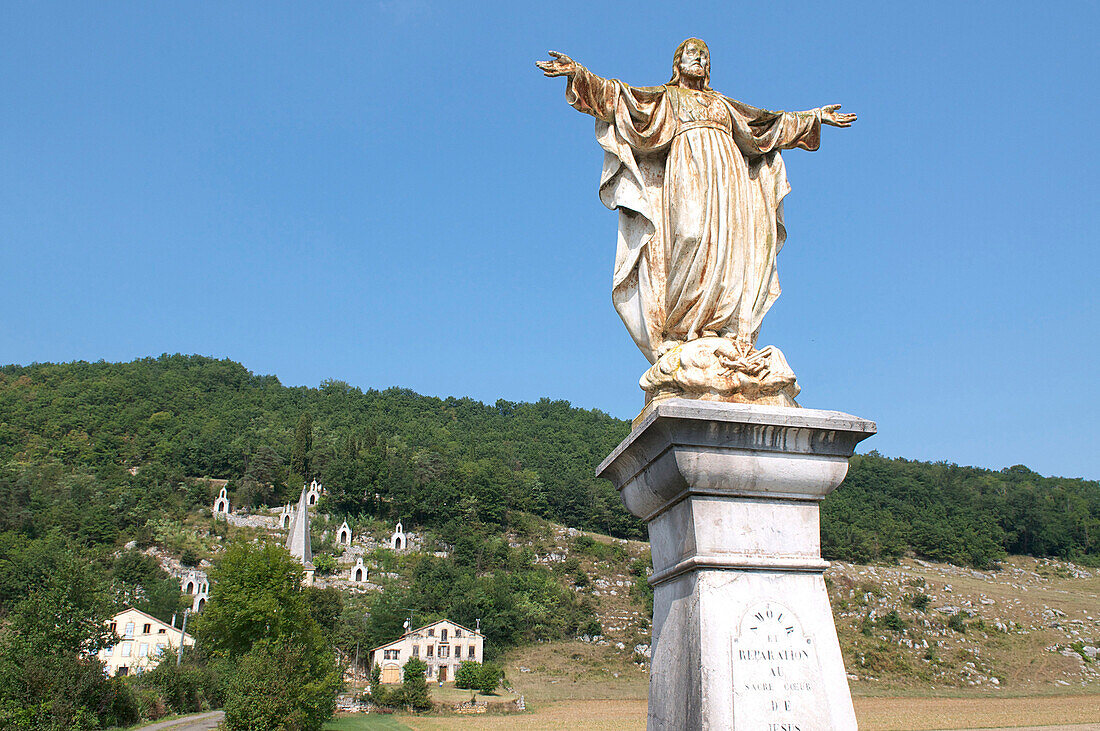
[733,601,829,731]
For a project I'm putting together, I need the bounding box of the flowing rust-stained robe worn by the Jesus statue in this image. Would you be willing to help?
[565,67,821,363]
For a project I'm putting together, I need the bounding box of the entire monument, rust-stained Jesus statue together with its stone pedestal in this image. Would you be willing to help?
[537,38,876,731]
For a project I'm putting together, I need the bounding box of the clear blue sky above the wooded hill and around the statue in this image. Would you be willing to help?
[0,0,1100,478]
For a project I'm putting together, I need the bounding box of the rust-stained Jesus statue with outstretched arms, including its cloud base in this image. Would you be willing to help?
[537,38,856,406]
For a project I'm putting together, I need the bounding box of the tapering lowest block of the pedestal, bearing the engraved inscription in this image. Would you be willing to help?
[648,549,856,731]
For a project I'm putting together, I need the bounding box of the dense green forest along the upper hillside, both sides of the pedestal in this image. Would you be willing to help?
[0,355,1100,567]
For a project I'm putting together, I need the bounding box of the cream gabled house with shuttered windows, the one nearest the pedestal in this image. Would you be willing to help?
[371,619,485,683]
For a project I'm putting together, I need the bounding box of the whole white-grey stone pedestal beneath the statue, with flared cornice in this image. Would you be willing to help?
[598,399,876,731]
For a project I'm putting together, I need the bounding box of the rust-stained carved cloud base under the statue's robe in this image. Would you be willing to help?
[639,337,800,407]
